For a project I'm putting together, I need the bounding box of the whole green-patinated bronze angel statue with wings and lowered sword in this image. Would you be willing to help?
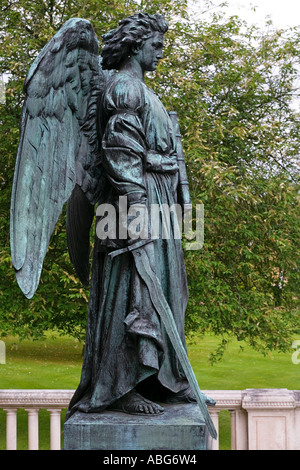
[11,13,216,437]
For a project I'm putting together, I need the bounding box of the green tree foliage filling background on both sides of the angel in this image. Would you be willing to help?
[0,0,300,357]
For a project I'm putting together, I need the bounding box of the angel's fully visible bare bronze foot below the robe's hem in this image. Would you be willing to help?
[109,391,164,416]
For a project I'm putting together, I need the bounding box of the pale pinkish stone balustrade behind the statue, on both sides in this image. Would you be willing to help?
[0,389,300,450]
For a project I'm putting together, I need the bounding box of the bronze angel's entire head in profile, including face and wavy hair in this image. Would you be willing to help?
[101,13,168,71]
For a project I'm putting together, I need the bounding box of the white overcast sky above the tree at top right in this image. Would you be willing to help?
[192,0,300,28]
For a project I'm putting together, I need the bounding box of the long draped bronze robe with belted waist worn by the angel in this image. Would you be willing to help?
[69,72,188,412]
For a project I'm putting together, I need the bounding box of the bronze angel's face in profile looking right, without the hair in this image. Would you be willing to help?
[135,31,164,72]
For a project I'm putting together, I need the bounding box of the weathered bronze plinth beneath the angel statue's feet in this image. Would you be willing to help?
[64,403,212,450]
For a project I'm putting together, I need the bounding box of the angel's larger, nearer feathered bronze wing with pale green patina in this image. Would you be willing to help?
[10,18,108,298]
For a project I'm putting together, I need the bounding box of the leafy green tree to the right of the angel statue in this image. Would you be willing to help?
[150,10,300,357]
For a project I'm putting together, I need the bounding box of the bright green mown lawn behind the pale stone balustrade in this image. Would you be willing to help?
[0,334,300,450]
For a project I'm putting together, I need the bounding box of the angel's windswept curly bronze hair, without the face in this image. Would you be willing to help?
[101,13,168,70]
